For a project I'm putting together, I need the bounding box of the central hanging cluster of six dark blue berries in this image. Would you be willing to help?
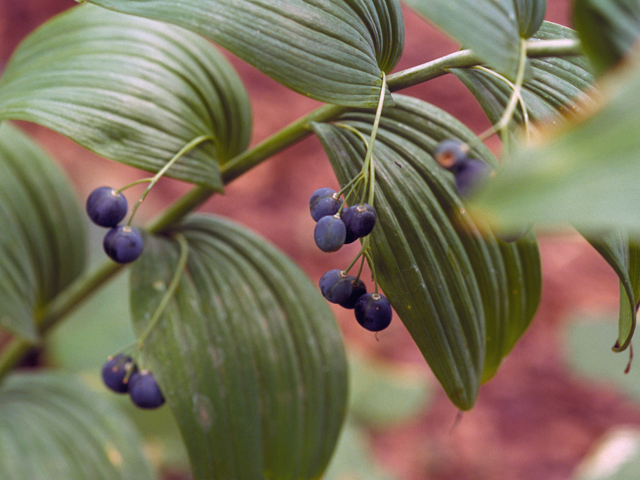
[309,188,392,332]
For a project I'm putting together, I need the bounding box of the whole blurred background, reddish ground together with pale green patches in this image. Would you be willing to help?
[0,0,640,480]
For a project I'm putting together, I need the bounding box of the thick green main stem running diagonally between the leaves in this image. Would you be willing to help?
[0,40,581,380]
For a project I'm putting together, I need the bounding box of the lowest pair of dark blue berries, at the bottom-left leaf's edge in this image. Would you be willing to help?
[102,355,165,409]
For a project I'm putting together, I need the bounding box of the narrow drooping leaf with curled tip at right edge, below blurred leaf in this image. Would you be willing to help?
[586,231,640,352]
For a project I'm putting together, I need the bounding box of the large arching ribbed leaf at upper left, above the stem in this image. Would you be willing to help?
[0,5,251,189]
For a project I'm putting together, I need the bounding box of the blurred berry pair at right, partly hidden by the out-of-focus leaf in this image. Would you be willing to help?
[433,139,491,198]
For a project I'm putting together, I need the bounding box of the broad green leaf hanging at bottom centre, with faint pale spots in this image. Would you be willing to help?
[131,215,347,480]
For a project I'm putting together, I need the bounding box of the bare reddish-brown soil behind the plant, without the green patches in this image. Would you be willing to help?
[0,0,640,480]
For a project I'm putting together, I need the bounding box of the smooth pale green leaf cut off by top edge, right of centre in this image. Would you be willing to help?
[405,0,528,80]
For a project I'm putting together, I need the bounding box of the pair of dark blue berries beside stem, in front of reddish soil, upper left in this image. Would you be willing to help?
[87,187,144,263]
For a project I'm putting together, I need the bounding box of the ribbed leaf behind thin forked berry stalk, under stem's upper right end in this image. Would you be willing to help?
[451,22,593,137]
